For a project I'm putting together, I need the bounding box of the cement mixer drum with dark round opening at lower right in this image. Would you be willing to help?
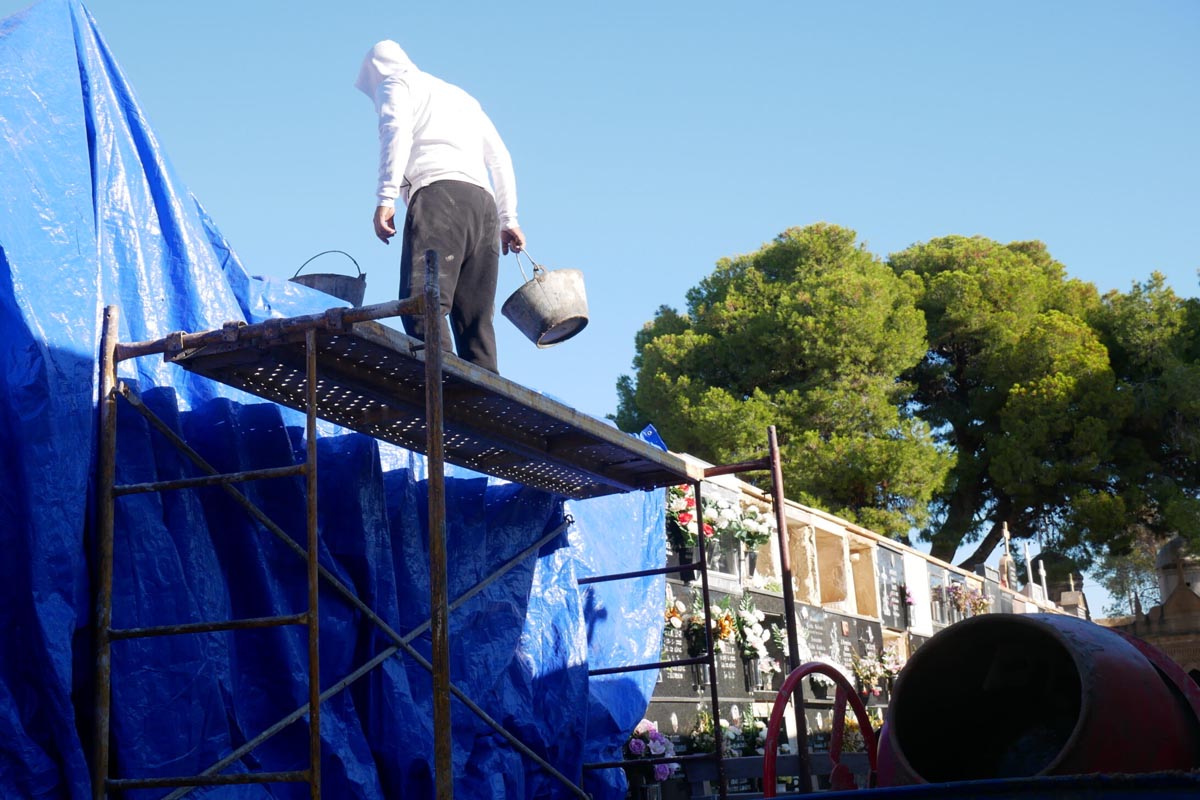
[878,614,1200,786]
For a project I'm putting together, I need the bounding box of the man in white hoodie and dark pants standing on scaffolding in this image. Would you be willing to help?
[354,40,524,372]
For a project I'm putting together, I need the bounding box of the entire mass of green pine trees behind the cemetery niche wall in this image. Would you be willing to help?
[617,224,1200,570]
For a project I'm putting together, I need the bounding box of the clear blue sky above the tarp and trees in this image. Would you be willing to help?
[7,0,1200,614]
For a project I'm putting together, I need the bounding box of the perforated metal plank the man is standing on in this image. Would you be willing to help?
[167,323,702,498]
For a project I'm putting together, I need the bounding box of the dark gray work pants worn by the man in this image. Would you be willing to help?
[400,181,500,372]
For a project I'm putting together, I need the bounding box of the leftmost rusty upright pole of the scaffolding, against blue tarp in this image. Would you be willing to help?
[91,306,120,800]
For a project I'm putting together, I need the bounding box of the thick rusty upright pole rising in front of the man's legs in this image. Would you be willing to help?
[424,249,454,800]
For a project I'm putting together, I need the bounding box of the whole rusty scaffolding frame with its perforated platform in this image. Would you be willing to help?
[92,273,768,800]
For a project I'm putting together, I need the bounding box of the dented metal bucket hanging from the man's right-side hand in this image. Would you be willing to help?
[500,253,588,348]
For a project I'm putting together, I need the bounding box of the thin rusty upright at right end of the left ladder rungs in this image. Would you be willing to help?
[304,327,320,800]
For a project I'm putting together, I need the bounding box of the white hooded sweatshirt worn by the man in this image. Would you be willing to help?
[354,40,517,229]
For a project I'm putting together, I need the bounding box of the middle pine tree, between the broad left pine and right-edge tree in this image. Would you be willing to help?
[890,236,1121,566]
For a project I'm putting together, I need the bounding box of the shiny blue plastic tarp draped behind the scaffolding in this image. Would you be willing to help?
[0,0,664,799]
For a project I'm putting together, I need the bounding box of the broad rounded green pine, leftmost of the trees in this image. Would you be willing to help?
[616,224,949,537]
